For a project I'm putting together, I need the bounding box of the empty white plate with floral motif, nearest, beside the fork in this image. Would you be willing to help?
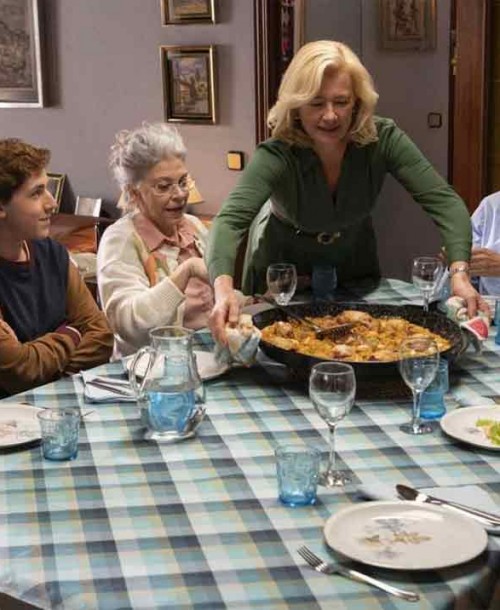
[324,502,488,570]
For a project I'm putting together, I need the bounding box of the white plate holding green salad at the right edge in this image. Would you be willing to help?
[441,406,500,451]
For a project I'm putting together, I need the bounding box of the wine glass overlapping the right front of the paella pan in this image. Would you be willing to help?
[399,336,439,434]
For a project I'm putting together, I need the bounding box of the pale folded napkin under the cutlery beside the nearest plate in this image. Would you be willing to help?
[357,483,500,536]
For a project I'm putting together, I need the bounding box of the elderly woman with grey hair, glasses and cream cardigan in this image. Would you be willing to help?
[97,123,213,358]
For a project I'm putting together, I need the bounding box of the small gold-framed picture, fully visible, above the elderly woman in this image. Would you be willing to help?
[160,46,216,123]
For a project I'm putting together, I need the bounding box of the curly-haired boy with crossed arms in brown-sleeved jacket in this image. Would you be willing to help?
[0,138,113,396]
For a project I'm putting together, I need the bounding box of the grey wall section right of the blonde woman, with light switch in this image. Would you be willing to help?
[362,0,450,279]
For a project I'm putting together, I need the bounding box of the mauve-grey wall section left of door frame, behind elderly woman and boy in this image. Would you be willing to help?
[0,0,255,212]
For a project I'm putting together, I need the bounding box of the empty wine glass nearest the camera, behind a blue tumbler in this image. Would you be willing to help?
[309,362,356,487]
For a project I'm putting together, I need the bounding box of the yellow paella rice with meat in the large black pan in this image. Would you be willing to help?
[262,310,451,362]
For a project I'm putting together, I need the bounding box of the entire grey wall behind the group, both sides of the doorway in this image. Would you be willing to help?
[0,0,458,278]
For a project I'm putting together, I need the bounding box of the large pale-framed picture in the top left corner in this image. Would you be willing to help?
[0,0,44,108]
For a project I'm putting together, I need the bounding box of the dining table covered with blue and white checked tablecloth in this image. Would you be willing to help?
[0,280,500,610]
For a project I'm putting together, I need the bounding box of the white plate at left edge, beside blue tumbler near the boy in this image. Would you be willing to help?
[0,403,43,448]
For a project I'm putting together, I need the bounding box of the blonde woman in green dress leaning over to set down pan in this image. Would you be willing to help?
[206,40,488,343]
